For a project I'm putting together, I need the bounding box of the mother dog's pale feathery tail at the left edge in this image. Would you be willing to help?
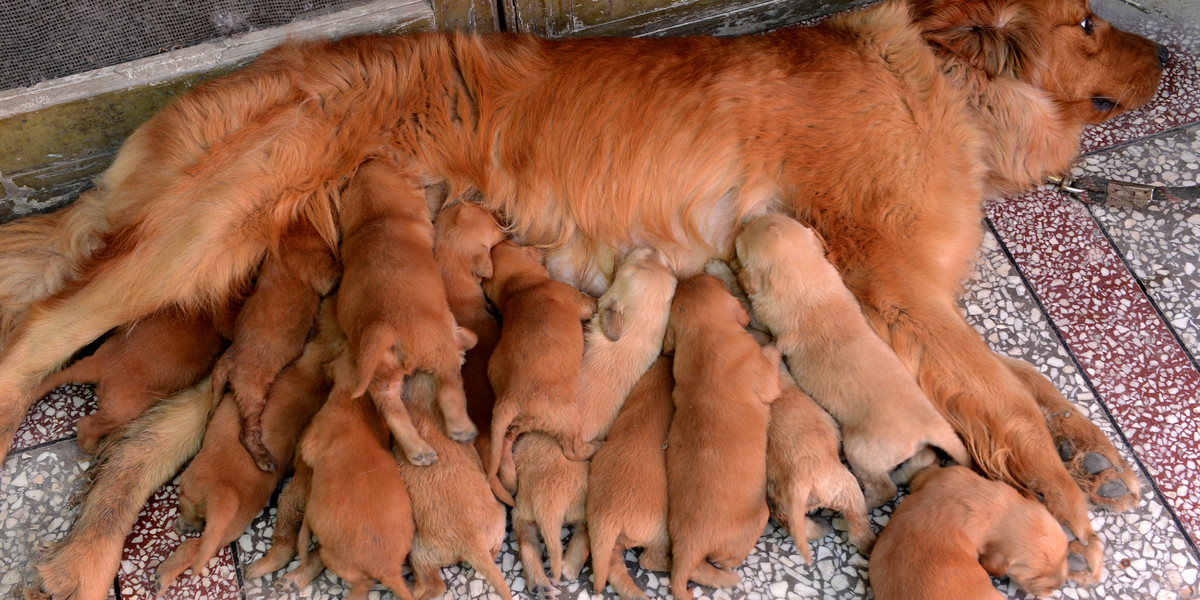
[0,188,108,337]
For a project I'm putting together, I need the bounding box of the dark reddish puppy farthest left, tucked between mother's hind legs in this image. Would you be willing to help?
[34,308,226,454]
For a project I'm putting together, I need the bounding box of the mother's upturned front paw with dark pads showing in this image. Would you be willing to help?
[1048,409,1141,511]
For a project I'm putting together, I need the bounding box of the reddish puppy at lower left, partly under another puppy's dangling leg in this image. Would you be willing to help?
[155,316,332,595]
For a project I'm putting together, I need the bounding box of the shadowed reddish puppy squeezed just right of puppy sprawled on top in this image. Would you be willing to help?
[433,200,505,432]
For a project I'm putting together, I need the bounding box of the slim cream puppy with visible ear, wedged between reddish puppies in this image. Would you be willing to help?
[577,247,676,451]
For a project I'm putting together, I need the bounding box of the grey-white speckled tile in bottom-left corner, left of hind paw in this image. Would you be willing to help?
[0,439,113,598]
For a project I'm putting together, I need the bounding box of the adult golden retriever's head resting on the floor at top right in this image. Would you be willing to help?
[911,0,1169,122]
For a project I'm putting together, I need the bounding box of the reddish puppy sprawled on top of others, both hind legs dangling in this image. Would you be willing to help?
[337,160,476,466]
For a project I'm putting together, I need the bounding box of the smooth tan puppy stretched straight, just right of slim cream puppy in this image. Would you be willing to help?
[662,275,780,599]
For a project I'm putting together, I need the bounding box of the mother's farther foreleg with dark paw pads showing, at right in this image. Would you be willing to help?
[1004,358,1140,510]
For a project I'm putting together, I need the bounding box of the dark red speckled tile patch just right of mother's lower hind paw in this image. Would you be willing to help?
[116,480,240,600]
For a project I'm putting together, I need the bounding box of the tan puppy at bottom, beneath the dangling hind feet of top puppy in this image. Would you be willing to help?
[397,373,512,600]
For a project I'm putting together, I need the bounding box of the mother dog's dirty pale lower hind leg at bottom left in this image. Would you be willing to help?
[25,380,212,600]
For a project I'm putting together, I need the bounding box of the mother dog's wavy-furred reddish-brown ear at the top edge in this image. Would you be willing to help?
[911,0,1046,79]
